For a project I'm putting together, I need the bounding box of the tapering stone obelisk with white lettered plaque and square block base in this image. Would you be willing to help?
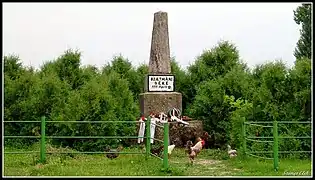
[140,11,182,117]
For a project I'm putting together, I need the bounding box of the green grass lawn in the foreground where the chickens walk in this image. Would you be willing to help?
[4,145,311,176]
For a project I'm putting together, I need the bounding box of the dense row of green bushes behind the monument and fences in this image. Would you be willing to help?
[3,37,311,157]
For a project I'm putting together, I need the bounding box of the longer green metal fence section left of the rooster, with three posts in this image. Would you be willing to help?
[4,116,169,169]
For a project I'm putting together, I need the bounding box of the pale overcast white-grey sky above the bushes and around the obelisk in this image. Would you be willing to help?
[2,3,300,68]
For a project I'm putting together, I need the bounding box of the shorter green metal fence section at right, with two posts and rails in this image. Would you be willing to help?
[242,119,312,171]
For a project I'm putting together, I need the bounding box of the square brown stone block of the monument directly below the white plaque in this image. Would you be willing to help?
[140,92,182,117]
